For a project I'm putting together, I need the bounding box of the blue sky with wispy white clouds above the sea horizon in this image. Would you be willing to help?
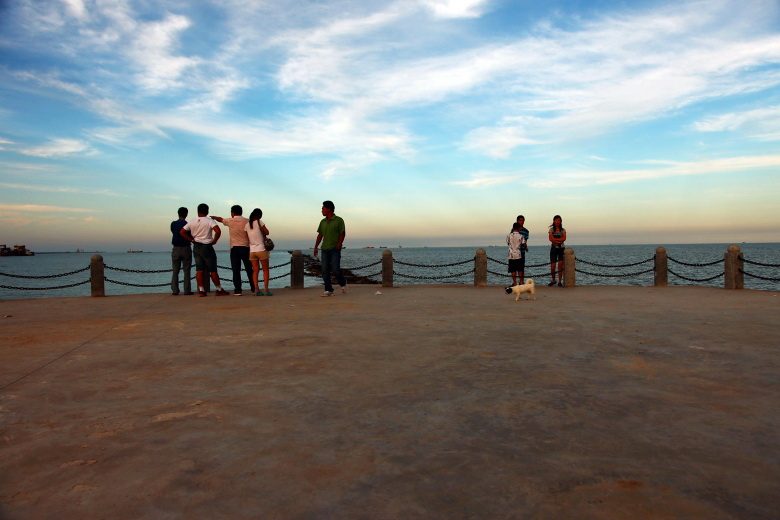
[0,0,780,251]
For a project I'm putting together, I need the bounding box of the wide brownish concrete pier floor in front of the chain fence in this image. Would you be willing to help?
[0,284,780,520]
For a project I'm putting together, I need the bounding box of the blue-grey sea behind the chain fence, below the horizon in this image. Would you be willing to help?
[0,243,780,300]
